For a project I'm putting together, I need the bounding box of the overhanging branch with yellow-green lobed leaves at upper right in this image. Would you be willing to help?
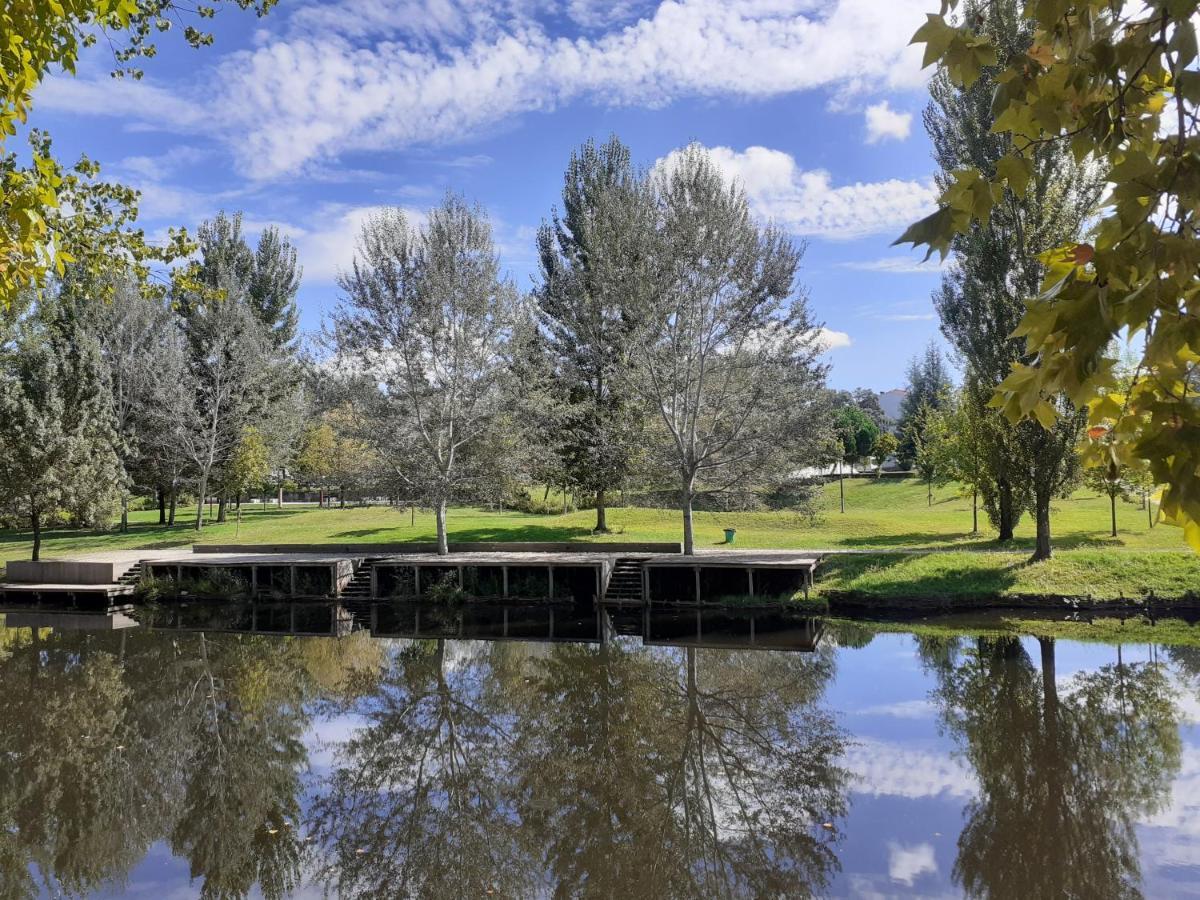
[896,0,1200,548]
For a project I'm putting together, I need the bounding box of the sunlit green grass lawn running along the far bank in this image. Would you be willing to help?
[0,479,1200,598]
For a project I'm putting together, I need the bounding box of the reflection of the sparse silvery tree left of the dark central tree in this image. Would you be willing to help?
[311,641,527,898]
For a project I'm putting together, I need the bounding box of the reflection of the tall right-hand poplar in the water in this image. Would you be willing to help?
[931,637,1181,898]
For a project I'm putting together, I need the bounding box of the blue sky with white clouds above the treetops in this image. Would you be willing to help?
[31,0,955,390]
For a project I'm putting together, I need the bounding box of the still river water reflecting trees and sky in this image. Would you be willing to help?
[0,607,1200,899]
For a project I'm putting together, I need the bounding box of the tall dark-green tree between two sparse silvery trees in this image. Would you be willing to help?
[534,137,654,532]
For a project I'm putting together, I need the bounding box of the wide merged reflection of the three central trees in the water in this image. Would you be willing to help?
[312,643,847,898]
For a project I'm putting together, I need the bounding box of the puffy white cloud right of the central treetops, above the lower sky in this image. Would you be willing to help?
[656,146,937,240]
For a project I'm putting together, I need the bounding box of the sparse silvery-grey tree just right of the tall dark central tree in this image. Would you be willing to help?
[629,145,828,553]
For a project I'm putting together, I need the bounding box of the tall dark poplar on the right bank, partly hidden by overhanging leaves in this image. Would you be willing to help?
[924,0,1102,559]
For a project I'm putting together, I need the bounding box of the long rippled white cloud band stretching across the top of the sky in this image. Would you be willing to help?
[60,0,926,177]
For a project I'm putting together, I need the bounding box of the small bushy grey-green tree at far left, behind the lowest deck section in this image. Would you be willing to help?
[0,299,122,560]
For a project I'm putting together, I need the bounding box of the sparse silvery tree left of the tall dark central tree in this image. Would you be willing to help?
[334,194,518,553]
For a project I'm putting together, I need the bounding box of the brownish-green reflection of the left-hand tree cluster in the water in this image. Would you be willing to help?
[0,629,374,899]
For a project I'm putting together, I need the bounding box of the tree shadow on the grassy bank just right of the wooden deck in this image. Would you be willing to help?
[817,553,1028,599]
